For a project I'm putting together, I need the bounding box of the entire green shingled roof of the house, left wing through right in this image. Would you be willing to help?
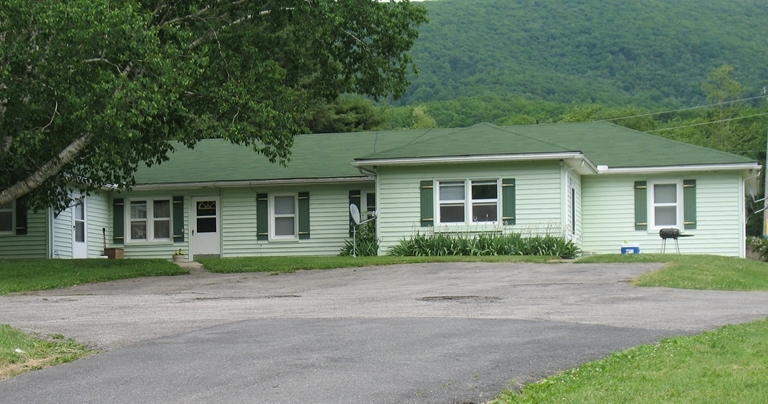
[136,122,754,184]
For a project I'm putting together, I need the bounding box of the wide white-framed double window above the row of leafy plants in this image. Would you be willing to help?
[436,180,499,224]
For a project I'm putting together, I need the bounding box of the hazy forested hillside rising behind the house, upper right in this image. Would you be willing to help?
[397,0,768,108]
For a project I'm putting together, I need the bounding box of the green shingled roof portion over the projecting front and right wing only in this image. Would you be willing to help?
[357,122,754,168]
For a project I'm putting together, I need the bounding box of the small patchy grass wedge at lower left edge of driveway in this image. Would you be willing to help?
[0,324,93,380]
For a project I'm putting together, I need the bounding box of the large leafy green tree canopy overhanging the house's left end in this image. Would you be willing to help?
[0,0,426,208]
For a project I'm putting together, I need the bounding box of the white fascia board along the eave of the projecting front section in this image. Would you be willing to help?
[352,152,597,172]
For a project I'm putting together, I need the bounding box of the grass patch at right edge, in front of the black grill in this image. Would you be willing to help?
[578,254,768,291]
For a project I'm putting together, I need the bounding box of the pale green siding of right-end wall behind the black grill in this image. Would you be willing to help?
[582,172,744,257]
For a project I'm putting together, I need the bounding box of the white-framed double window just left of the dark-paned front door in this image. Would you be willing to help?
[127,198,171,241]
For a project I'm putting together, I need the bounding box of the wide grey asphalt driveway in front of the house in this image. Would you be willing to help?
[0,263,768,403]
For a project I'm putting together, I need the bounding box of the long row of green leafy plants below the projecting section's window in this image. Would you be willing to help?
[389,232,580,259]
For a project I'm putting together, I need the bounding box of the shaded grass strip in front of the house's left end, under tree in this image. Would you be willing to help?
[0,259,189,295]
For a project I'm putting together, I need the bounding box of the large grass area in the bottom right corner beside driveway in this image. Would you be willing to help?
[493,320,768,404]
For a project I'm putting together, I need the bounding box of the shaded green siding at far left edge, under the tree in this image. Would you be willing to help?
[0,210,48,259]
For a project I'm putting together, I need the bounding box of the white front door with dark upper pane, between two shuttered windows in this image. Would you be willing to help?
[190,197,221,259]
